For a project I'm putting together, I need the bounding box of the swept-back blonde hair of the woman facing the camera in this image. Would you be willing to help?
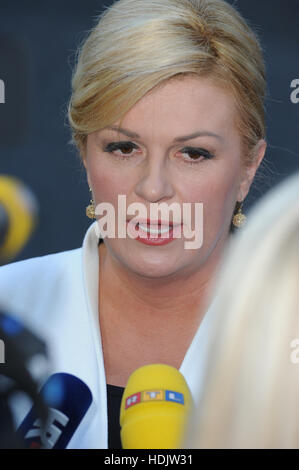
[68,0,266,163]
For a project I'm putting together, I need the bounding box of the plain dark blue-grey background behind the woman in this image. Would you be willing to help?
[0,0,299,260]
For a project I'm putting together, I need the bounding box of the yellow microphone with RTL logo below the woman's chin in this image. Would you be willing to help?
[120,364,193,449]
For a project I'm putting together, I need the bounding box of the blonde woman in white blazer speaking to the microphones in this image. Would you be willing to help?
[0,0,266,448]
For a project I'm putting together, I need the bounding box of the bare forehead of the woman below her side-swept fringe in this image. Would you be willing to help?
[115,77,240,137]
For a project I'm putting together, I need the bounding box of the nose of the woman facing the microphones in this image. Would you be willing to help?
[135,158,174,202]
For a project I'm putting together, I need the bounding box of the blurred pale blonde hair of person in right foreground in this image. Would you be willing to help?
[184,173,299,448]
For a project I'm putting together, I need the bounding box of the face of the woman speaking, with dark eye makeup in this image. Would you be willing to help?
[84,77,265,278]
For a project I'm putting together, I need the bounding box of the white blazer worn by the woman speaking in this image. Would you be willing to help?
[0,221,214,449]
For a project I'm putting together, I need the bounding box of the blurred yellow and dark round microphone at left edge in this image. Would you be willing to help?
[0,175,38,265]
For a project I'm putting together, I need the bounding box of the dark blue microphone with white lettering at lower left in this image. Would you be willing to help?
[17,373,92,449]
